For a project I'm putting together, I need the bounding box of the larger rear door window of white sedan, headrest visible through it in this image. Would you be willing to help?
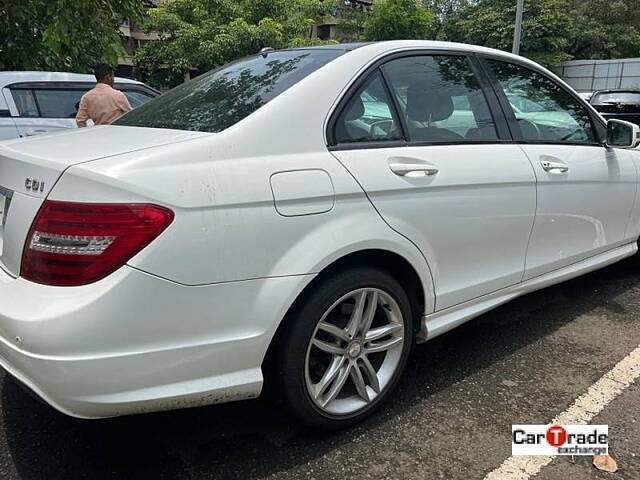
[383,55,498,143]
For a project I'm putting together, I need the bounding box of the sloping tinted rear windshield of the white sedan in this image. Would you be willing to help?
[114,49,344,132]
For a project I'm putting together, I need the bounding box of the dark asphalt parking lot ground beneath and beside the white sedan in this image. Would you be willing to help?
[0,262,640,480]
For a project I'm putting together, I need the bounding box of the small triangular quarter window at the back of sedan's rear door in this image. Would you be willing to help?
[335,72,402,143]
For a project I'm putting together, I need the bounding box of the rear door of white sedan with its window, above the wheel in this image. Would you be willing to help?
[330,54,535,310]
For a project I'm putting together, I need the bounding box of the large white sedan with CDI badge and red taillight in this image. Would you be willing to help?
[0,41,640,428]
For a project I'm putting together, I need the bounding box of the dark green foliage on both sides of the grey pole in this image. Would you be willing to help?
[444,0,640,65]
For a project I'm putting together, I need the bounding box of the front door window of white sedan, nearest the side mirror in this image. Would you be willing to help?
[489,60,596,144]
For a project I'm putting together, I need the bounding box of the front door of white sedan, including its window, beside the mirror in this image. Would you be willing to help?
[486,59,637,279]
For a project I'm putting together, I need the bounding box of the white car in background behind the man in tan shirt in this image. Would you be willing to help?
[0,72,160,141]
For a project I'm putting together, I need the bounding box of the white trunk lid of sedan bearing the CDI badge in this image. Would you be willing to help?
[0,126,212,276]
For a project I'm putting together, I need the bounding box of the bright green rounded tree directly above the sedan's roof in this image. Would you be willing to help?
[364,0,435,40]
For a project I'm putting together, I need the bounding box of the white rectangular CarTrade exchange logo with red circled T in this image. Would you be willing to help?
[511,425,609,455]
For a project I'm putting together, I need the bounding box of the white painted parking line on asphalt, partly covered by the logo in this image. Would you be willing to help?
[484,345,640,480]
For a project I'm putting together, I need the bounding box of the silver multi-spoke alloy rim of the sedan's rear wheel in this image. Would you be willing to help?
[305,288,404,415]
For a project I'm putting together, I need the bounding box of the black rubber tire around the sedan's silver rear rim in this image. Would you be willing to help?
[272,267,413,430]
